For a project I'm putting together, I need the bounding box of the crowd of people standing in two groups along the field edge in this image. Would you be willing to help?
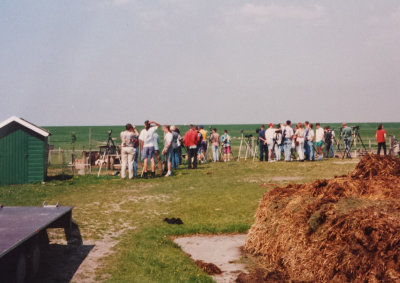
[120,120,386,179]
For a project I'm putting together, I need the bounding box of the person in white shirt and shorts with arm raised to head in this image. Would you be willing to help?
[139,120,160,178]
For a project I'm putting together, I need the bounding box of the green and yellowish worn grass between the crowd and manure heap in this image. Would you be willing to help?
[0,160,355,282]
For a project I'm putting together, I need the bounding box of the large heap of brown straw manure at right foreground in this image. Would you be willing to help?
[245,155,400,282]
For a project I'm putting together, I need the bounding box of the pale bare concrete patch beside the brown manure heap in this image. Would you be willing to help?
[174,234,246,282]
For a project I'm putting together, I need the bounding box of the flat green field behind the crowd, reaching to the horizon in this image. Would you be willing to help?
[44,123,400,150]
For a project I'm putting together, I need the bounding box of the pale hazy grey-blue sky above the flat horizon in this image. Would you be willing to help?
[0,0,400,126]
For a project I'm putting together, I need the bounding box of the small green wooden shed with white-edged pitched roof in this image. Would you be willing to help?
[0,116,50,185]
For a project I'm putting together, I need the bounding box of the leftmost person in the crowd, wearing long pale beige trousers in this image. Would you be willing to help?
[120,123,137,179]
